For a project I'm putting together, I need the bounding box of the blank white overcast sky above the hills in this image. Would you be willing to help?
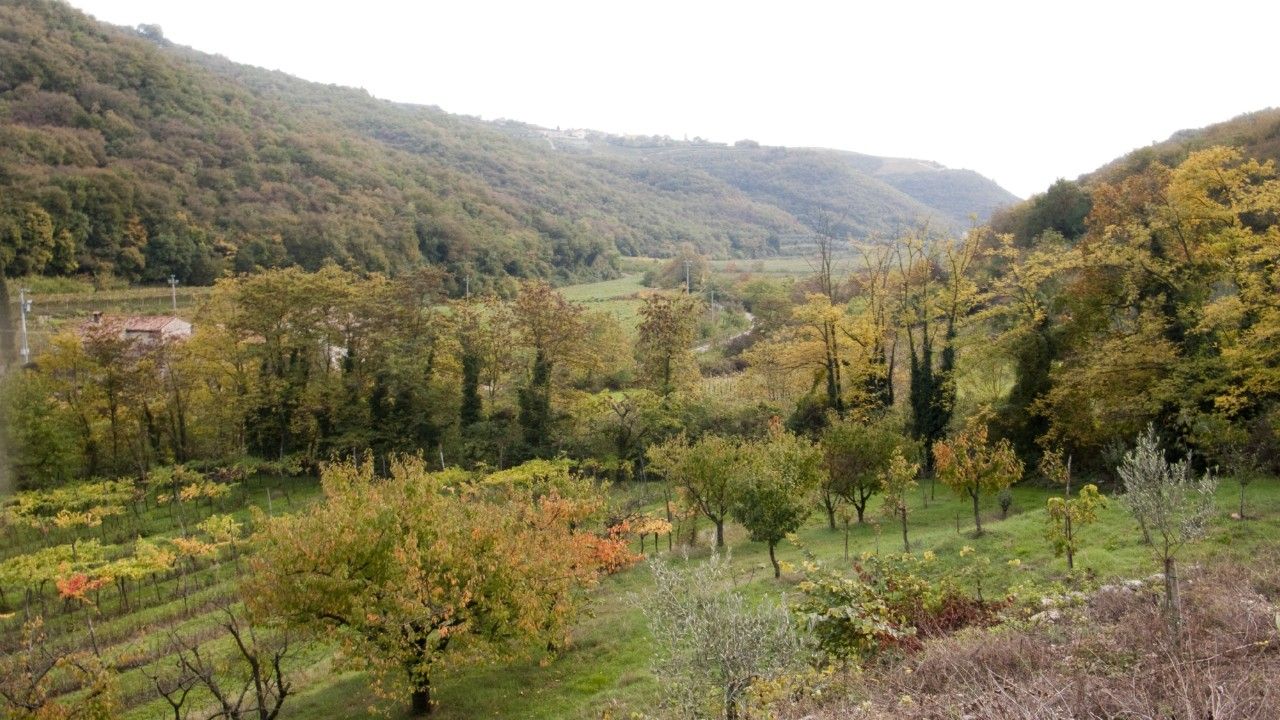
[70,0,1280,196]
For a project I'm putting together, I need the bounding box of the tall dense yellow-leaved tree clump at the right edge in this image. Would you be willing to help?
[1039,147,1280,455]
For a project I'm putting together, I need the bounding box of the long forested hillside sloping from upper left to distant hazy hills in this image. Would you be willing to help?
[0,0,1011,292]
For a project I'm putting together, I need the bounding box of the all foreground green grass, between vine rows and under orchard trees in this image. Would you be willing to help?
[0,450,1280,720]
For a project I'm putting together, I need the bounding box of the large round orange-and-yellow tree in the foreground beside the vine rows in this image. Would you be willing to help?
[246,457,614,715]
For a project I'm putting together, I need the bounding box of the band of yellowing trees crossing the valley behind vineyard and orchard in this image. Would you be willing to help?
[9,142,1280,486]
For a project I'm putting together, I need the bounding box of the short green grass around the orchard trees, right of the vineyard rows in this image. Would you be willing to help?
[284,480,1280,719]
